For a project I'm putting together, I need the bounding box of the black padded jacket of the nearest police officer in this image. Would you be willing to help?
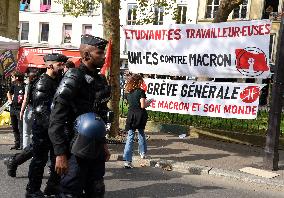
[48,64,110,155]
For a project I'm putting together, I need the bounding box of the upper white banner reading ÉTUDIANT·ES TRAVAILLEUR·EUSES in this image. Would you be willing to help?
[124,20,271,78]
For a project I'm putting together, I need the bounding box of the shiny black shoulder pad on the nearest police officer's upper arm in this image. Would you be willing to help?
[54,68,84,104]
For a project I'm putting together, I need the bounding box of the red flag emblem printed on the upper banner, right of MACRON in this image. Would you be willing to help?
[235,49,269,71]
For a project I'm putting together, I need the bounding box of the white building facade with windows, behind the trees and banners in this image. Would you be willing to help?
[19,0,284,64]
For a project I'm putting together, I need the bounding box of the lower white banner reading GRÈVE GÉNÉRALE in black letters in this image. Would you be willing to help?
[145,79,264,119]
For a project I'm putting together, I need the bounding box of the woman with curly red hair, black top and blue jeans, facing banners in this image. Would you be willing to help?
[123,74,151,168]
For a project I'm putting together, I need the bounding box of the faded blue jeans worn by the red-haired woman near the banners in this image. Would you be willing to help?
[123,129,147,162]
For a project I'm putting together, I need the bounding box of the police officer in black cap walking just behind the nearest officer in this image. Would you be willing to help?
[26,54,68,198]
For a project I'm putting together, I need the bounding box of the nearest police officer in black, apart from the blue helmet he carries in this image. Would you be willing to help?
[48,35,110,198]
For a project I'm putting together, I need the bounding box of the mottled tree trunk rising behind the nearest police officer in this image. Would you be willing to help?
[102,0,120,137]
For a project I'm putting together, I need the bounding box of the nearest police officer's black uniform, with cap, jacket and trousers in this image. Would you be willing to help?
[48,35,110,198]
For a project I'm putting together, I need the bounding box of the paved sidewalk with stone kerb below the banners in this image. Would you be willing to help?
[107,132,284,187]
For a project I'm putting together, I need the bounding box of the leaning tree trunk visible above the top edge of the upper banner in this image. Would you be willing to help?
[213,0,244,23]
